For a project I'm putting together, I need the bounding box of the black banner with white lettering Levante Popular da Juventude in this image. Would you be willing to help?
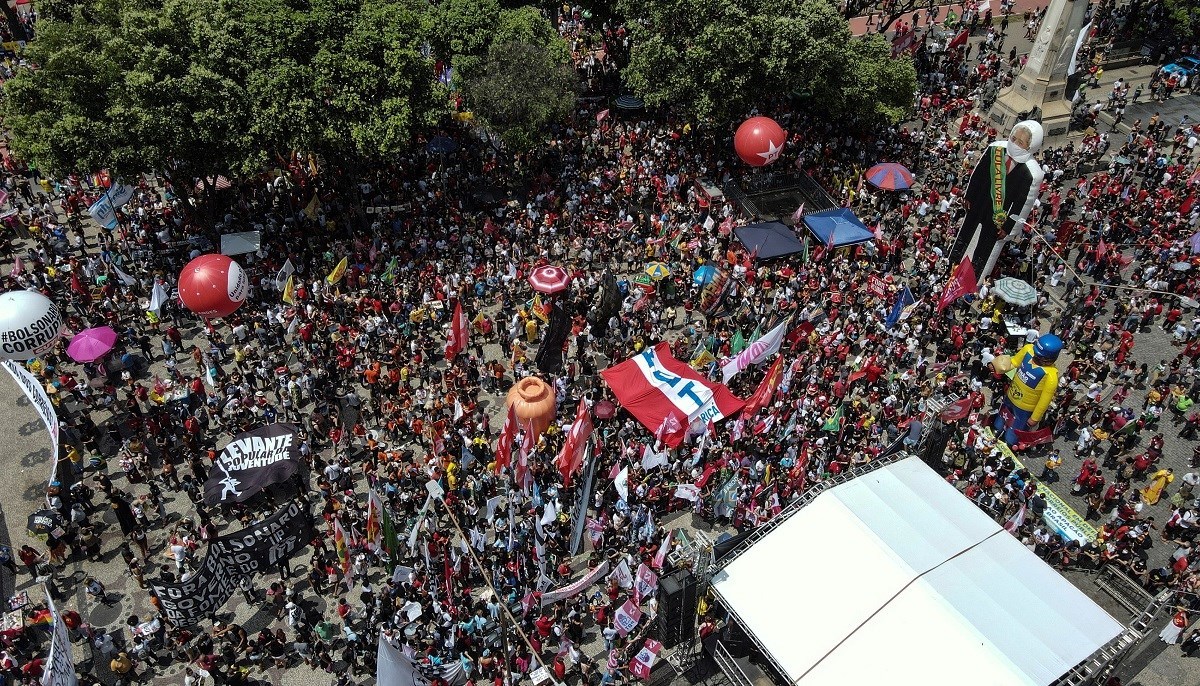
[204,423,300,505]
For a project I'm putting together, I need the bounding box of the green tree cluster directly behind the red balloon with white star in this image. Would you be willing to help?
[618,0,916,122]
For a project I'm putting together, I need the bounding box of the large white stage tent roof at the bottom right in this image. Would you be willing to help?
[713,457,1123,686]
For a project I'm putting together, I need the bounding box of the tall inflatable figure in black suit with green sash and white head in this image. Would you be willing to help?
[950,120,1045,283]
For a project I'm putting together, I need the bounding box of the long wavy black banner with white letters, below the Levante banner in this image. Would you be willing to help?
[150,501,312,626]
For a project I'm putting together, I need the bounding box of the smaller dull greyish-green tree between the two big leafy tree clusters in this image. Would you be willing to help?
[463,41,580,151]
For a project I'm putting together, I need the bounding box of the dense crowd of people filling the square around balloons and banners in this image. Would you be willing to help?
[0,1,1200,685]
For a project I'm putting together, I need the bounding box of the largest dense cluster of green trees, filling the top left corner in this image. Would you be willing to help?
[0,0,444,180]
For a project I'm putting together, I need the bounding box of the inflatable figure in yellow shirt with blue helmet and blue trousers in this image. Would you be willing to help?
[995,333,1062,445]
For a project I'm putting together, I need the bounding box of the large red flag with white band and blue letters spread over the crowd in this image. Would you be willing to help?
[600,342,745,447]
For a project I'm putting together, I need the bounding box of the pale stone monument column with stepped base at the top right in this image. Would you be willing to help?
[988,0,1087,139]
